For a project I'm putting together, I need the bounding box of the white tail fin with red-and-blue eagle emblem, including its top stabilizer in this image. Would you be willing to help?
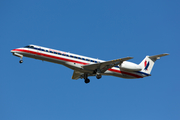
[139,53,169,74]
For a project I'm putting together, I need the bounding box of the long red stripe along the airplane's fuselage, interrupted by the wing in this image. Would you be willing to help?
[12,49,142,78]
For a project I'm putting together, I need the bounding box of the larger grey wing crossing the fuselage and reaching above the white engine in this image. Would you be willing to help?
[82,57,133,73]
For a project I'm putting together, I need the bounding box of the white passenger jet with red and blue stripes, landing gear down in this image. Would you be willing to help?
[11,44,169,83]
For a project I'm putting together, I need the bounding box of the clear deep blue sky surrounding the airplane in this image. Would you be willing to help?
[0,0,180,120]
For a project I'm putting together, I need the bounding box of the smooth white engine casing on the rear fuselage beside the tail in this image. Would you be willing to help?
[120,61,142,71]
